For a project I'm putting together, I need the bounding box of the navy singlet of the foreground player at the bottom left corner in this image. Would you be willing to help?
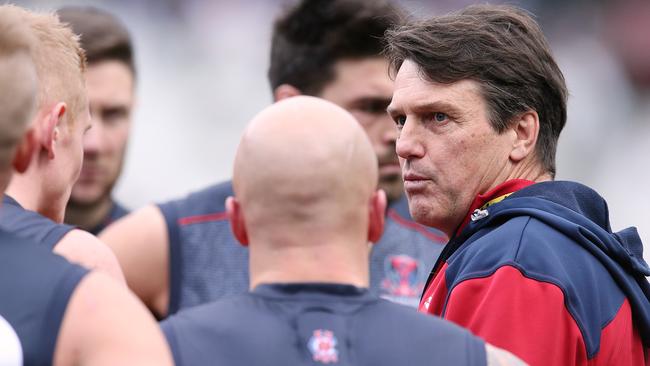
[0,229,88,365]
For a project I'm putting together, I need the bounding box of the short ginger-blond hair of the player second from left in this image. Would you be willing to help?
[0,5,88,125]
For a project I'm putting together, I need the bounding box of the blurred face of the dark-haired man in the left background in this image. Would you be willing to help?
[70,61,133,205]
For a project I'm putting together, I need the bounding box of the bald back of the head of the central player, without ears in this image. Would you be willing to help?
[233,96,377,231]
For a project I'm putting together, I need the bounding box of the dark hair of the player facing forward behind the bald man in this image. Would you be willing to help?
[268,0,403,95]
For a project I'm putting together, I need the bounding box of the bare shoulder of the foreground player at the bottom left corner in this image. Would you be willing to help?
[54,272,172,366]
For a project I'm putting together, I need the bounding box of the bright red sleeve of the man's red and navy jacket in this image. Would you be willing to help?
[444,266,587,365]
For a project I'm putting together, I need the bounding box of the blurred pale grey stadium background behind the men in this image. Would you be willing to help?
[10,0,650,258]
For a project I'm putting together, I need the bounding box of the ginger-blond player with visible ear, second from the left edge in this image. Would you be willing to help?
[0,6,123,281]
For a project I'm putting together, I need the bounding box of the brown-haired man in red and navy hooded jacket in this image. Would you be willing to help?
[387,5,650,365]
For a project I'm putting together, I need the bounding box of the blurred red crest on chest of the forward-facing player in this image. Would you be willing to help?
[381,255,424,297]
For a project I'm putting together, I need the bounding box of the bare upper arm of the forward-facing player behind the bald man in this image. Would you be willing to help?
[100,206,169,318]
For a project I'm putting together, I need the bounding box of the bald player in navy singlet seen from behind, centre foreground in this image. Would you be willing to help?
[162,96,524,365]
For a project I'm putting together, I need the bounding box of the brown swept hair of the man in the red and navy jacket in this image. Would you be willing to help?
[386,5,568,176]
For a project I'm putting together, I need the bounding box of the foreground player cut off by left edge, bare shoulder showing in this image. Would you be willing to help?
[0,5,171,366]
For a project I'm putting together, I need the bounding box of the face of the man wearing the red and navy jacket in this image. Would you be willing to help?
[388,60,512,236]
